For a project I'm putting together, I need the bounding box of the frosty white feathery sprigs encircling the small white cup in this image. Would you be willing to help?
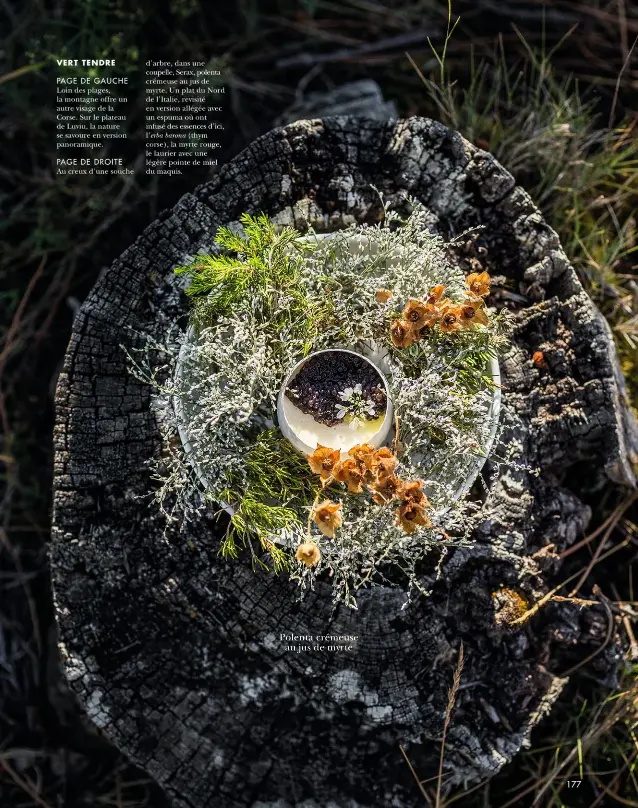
[131,203,506,606]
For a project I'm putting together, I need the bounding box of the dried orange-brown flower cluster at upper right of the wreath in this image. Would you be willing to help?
[388,272,490,348]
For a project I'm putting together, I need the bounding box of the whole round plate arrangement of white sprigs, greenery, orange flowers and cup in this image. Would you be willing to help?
[131,200,509,606]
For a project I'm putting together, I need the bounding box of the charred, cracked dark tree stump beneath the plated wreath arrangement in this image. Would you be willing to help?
[51,117,638,808]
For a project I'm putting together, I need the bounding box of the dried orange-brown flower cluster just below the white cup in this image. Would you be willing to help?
[298,443,432,548]
